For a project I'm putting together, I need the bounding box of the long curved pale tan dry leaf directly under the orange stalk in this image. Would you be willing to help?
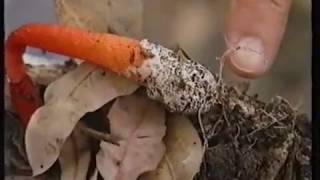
[25,63,138,175]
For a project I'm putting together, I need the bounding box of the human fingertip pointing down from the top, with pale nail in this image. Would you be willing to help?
[225,0,292,79]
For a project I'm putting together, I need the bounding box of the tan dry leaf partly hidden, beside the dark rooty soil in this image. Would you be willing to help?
[140,115,203,180]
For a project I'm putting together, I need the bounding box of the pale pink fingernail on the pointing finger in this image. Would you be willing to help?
[229,37,267,78]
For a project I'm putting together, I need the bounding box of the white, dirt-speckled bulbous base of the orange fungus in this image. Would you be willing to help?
[127,39,217,114]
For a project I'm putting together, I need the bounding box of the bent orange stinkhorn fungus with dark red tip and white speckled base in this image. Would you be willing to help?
[5,24,217,125]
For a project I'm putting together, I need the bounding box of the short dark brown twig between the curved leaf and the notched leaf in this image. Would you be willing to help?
[78,123,120,146]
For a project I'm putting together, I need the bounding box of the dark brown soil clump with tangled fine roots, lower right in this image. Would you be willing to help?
[193,86,311,180]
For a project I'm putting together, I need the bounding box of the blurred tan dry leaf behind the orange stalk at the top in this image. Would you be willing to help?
[55,0,143,38]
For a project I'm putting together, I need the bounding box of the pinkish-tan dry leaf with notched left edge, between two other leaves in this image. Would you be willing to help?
[97,94,166,180]
